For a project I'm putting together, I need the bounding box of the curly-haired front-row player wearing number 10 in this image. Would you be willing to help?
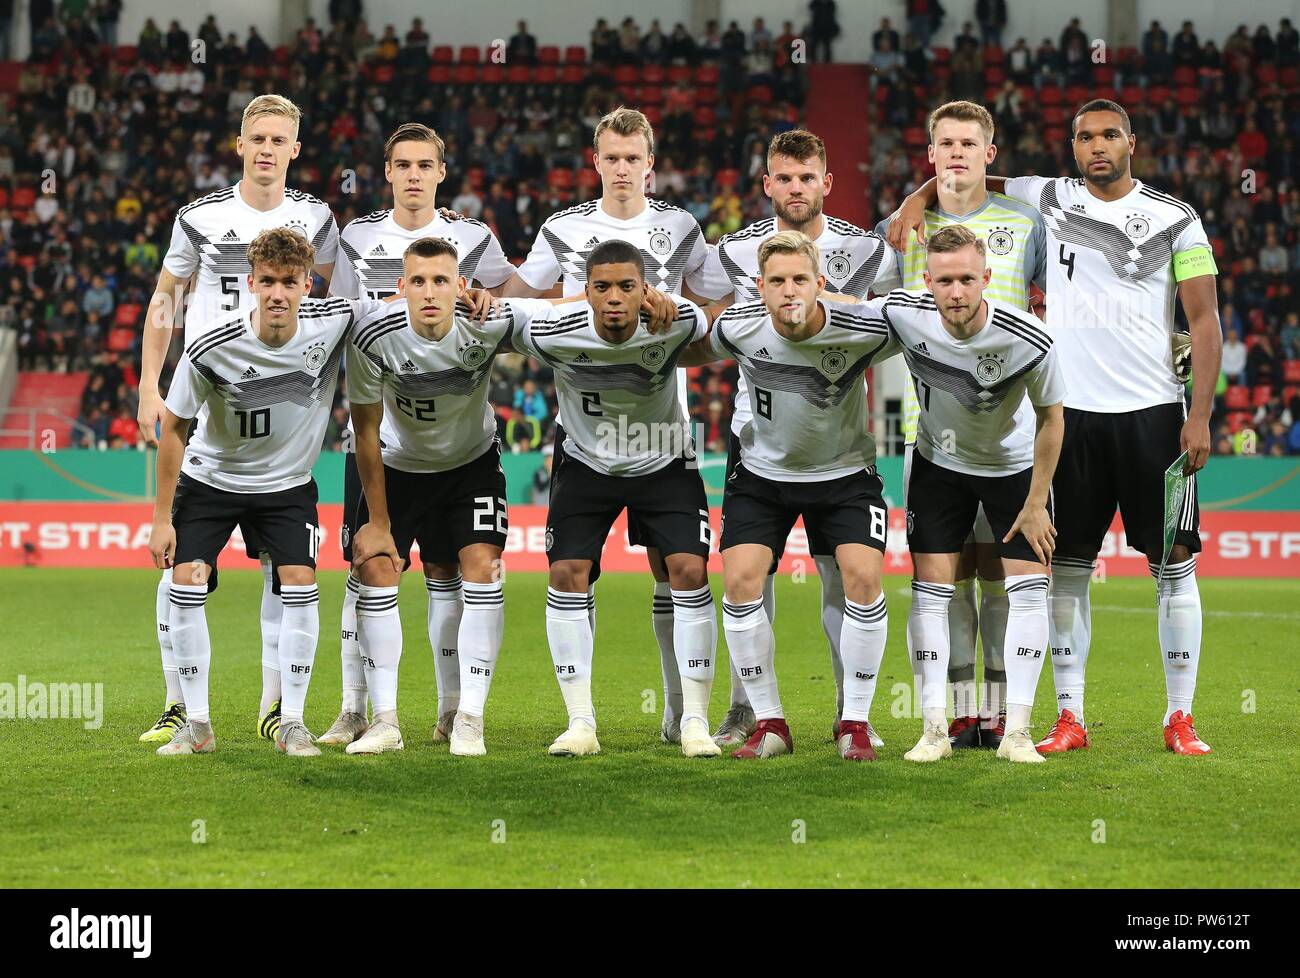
[150,228,377,756]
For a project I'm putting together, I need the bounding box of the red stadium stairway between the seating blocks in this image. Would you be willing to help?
[806,62,875,230]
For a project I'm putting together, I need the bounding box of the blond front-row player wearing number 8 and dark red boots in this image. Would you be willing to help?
[686,231,898,761]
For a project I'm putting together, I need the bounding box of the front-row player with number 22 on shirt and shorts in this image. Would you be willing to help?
[343,238,525,756]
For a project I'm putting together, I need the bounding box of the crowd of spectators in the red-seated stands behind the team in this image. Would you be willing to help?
[0,0,1300,454]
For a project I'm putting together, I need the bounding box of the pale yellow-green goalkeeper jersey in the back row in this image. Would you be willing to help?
[872,194,1047,445]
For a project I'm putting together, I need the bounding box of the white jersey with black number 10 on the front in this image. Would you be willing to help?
[166,299,381,493]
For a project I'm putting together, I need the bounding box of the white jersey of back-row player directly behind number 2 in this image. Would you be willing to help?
[519,198,709,295]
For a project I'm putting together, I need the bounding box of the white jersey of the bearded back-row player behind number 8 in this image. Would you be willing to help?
[690,215,891,434]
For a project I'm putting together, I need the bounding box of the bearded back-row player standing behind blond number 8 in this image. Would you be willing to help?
[694,129,892,748]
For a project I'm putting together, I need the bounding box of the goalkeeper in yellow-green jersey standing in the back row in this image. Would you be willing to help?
[876,101,1047,748]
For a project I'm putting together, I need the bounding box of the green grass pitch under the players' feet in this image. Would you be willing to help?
[0,568,1300,887]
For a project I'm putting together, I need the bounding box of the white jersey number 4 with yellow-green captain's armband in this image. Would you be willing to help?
[1005,177,1217,412]
